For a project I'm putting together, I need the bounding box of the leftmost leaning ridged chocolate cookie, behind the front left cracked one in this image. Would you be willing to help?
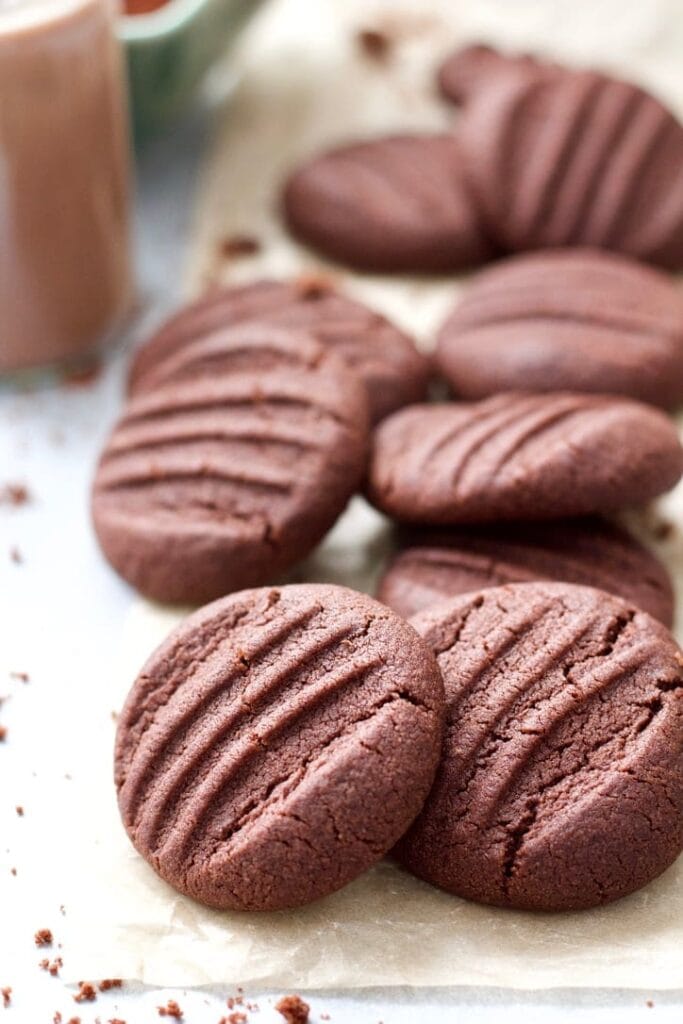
[93,325,368,603]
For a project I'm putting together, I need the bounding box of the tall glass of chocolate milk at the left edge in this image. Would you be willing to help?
[0,0,130,371]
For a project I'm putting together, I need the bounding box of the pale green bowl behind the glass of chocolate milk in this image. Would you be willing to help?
[119,0,263,141]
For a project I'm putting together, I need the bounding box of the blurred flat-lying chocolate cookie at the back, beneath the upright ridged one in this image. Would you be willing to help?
[284,134,490,273]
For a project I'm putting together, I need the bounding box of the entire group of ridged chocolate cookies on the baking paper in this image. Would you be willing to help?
[93,47,683,910]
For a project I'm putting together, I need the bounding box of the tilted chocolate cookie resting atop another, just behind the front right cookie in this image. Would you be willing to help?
[368,391,683,523]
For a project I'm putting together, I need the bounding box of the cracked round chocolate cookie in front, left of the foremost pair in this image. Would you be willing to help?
[116,584,443,910]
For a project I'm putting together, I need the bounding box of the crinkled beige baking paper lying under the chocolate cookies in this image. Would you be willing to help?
[67,0,683,989]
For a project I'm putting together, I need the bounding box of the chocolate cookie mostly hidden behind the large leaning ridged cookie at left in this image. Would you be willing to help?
[129,279,430,422]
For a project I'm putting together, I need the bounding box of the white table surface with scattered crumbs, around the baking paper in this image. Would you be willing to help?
[0,90,683,1024]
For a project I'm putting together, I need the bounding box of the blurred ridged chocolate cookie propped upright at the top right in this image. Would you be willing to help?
[441,49,683,269]
